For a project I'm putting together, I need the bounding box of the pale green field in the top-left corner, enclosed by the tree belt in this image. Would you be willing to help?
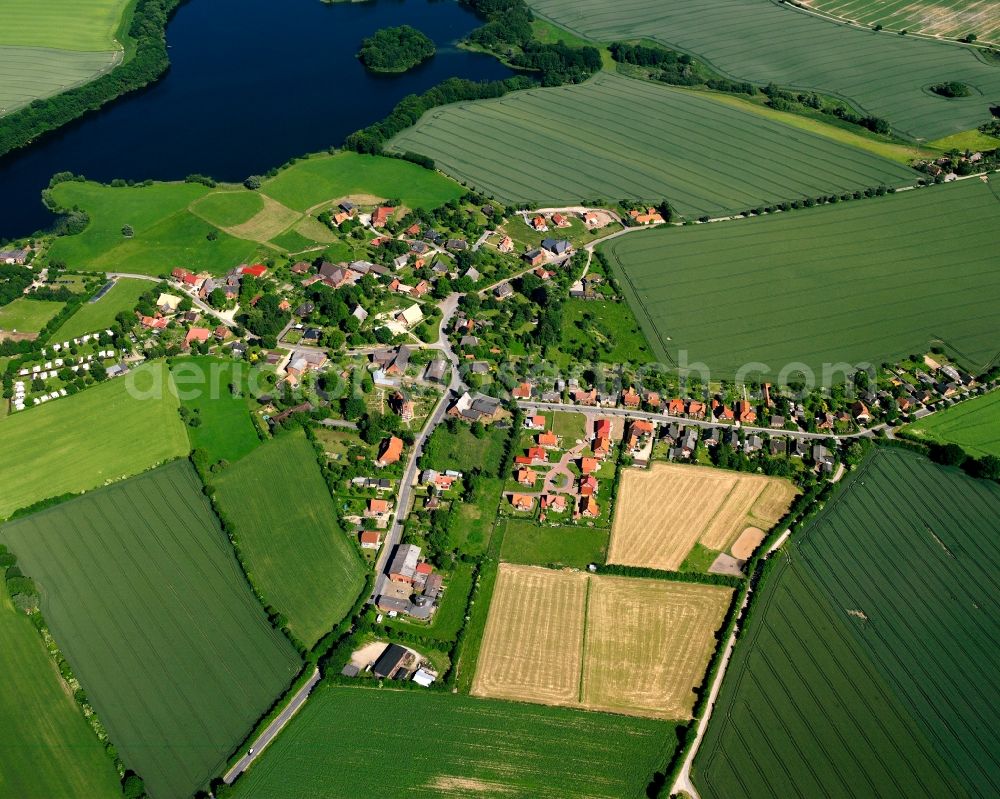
[0,0,129,116]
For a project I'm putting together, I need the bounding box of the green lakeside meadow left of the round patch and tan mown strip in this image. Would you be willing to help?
[49,181,258,275]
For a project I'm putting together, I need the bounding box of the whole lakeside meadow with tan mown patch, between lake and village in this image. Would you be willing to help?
[49,153,463,276]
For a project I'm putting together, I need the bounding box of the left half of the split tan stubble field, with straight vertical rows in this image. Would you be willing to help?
[472,563,588,705]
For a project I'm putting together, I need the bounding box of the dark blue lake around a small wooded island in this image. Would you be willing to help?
[0,0,512,239]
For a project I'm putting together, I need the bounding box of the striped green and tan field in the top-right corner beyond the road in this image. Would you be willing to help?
[805,0,1000,44]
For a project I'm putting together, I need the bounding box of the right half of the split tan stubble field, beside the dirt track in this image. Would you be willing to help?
[581,576,732,719]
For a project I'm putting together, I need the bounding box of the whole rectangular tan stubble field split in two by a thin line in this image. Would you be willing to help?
[472,563,732,719]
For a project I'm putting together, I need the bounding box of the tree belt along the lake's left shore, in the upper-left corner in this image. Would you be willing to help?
[0,0,181,155]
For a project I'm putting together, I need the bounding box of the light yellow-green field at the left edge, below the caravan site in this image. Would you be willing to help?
[0,363,188,518]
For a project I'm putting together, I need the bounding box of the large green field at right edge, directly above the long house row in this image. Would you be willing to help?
[604,180,1000,383]
